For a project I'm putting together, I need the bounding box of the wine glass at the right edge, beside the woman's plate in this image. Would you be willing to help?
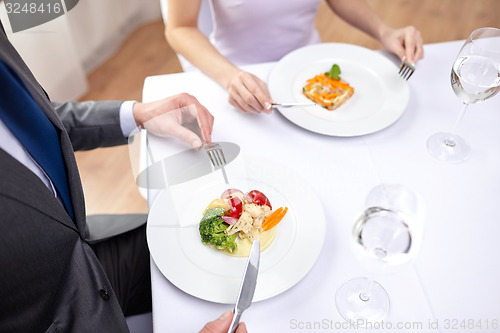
[427,28,500,163]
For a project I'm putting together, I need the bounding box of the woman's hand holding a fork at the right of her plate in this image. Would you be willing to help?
[380,26,424,64]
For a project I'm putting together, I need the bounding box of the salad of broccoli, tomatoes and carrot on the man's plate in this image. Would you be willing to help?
[199,189,288,257]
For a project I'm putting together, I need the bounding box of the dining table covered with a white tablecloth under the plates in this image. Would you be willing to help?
[143,40,500,333]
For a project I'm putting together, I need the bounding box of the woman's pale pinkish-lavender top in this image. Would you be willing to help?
[210,0,322,65]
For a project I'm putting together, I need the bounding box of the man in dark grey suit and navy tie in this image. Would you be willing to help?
[0,18,246,333]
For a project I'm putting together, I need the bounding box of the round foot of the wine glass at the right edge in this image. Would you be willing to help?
[427,133,471,163]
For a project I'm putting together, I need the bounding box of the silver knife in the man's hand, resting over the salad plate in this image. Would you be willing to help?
[227,240,260,333]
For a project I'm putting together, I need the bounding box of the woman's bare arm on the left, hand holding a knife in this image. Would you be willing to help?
[165,0,271,113]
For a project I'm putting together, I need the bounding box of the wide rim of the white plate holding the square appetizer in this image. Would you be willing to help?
[268,43,410,137]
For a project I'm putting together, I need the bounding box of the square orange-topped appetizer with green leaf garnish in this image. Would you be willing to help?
[302,64,354,110]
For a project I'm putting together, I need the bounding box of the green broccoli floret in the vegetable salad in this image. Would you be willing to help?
[199,208,236,252]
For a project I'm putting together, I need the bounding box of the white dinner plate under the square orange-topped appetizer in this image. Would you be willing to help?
[268,43,410,136]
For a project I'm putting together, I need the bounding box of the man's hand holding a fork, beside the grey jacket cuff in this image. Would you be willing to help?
[133,93,214,148]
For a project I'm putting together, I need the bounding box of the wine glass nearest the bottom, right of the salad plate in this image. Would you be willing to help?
[335,184,423,325]
